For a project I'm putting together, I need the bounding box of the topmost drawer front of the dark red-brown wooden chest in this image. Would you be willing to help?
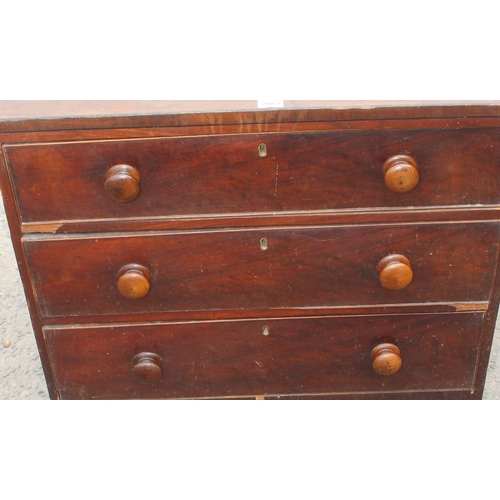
[5,129,500,222]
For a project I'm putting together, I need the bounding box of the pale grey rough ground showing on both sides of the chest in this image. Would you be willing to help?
[0,196,500,399]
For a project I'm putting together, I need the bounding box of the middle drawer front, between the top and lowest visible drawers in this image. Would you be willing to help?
[24,224,498,318]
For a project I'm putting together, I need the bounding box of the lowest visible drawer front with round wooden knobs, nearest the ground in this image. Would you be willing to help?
[44,313,483,399]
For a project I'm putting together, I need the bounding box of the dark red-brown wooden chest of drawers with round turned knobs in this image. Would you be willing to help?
[0,101,500,399]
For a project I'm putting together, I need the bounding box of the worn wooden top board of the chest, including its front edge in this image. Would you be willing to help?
[0,100,500,132]
